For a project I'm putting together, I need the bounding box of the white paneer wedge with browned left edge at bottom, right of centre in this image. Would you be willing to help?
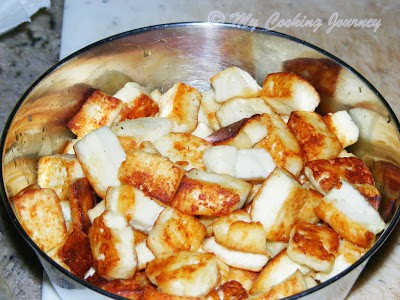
[250,250,310,295]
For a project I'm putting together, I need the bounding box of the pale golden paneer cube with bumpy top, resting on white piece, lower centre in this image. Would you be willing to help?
[213,210,267,254]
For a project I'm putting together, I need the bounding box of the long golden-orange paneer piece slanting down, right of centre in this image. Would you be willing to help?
[255,113,303,176]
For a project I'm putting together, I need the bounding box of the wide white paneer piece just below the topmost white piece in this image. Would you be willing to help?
[216,97,272,127]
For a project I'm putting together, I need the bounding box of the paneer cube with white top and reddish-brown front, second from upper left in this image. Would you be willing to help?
[114,82,159,122]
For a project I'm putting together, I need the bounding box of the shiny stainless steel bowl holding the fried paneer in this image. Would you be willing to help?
[0,23,400,299]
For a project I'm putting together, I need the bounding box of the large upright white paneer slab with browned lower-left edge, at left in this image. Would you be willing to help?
[74,127,126,199]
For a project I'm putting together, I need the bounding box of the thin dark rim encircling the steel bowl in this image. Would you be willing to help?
[0,22,400,300]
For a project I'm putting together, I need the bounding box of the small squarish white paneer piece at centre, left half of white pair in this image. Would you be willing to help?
[203,145,238,176]
